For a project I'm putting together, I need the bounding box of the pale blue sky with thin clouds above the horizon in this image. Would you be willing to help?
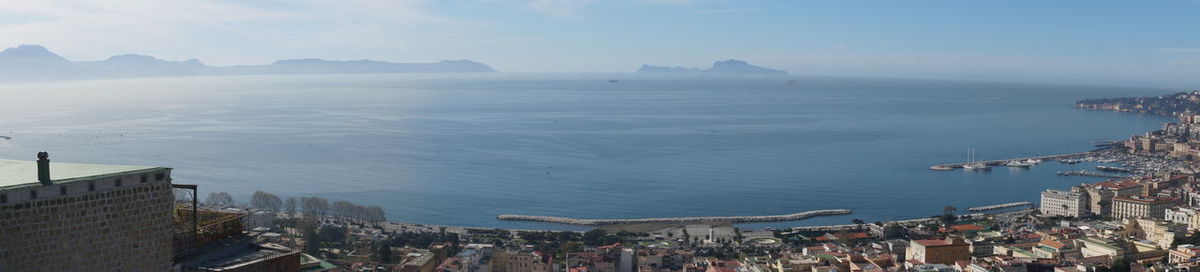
[0,0,1200,86]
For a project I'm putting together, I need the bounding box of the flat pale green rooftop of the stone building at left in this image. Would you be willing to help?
[0,159,167,189]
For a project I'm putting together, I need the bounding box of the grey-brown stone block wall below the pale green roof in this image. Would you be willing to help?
[0,169,174,272]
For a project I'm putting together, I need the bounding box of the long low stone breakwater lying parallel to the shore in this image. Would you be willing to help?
[496,208,852,225]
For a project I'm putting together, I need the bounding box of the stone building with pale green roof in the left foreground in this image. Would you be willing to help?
[0,152,174,272]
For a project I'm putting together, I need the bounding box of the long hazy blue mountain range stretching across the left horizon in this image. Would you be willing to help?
[0,44,496,80]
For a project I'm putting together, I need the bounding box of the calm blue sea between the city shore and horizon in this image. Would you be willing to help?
[0,74,1175,229]
